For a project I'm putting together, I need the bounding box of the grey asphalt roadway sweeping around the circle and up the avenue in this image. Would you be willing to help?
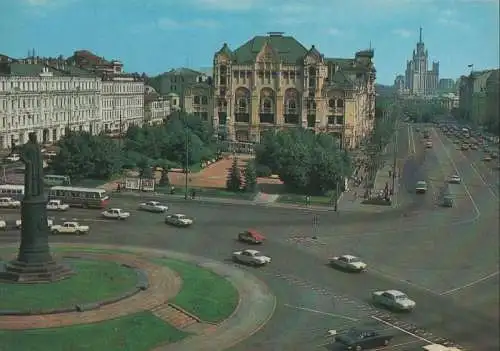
[0,125,499,351]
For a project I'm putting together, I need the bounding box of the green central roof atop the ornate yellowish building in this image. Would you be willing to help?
[230,35,308,64]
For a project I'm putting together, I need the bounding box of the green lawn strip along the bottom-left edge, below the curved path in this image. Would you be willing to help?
[0,312,190,351]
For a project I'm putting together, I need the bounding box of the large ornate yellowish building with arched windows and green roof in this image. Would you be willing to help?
[213,32,376,148]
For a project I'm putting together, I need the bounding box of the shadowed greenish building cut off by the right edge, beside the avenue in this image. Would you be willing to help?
[459,69,500,126]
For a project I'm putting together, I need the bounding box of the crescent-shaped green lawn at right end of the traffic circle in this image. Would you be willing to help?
[155,259,239,322]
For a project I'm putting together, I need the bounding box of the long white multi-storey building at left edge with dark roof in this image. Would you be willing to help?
[0,62,101,149]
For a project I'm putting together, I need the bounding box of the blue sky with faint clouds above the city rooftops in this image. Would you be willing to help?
[0,0,499,84]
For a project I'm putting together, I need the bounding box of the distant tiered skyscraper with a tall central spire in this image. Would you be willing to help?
[405,27,439,96]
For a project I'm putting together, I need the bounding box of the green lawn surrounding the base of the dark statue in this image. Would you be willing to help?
[0,259,137,311]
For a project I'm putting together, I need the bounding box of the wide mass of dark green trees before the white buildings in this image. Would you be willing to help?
[52,112,216,182]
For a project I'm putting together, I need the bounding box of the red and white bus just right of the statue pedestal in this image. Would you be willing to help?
[49,186,109,208]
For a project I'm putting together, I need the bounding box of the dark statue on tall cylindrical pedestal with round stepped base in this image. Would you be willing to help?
[0,133,73,283]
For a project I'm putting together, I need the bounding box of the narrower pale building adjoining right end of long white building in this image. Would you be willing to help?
[101,74,145,134]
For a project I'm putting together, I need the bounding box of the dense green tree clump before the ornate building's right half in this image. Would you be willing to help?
[256,129,351,195]
